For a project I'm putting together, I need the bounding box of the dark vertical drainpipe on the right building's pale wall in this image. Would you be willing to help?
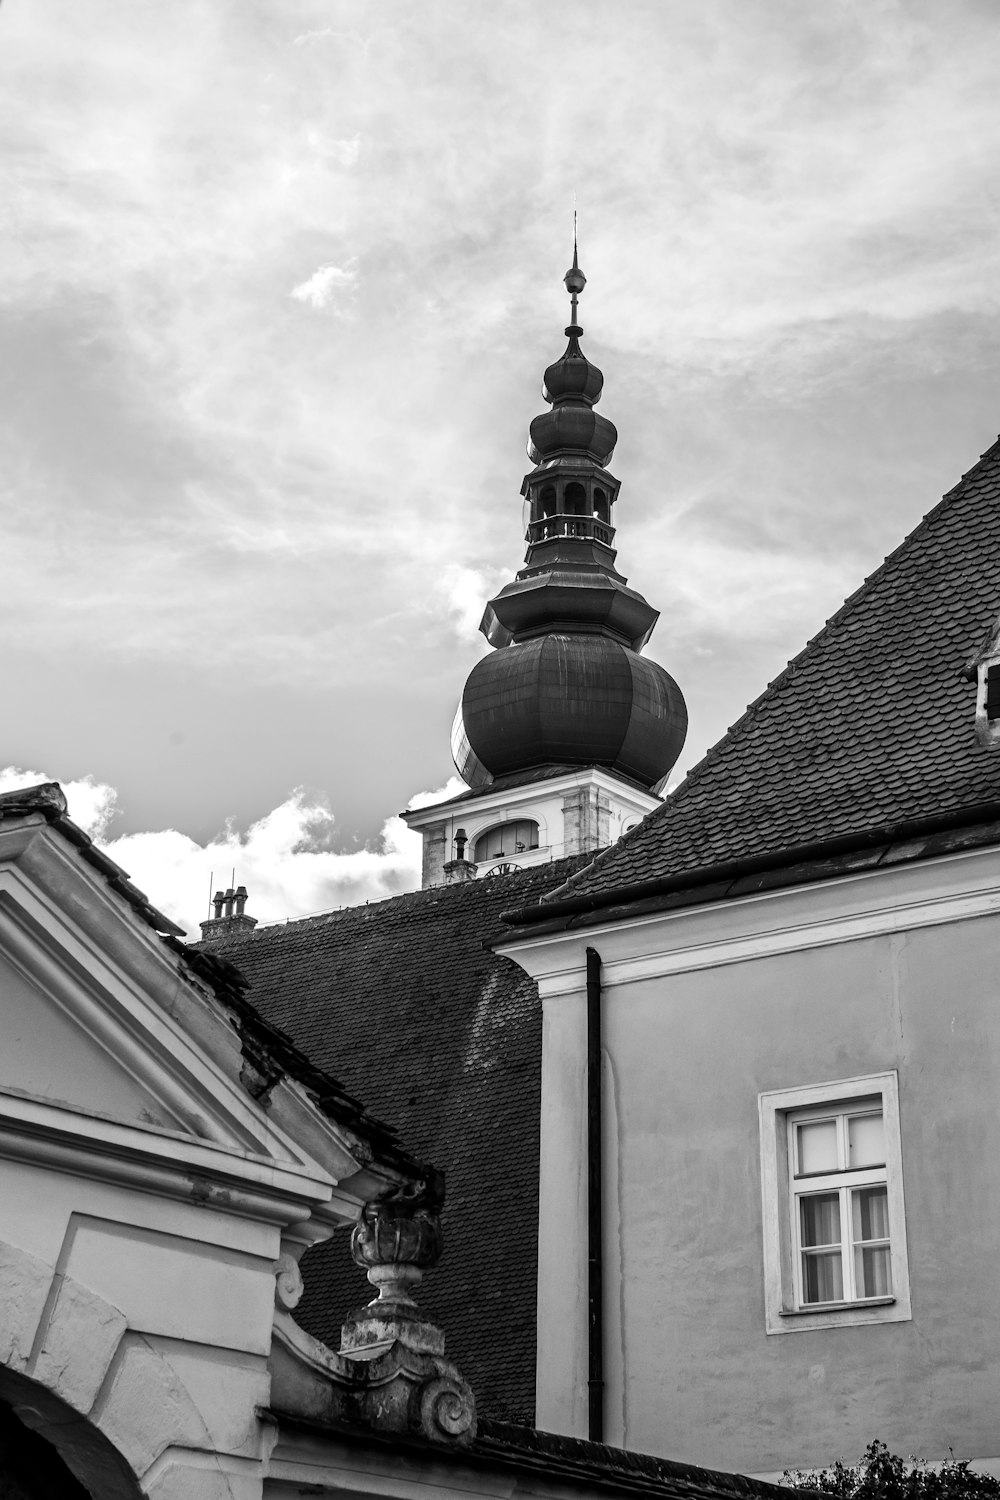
[586,948,604,1443]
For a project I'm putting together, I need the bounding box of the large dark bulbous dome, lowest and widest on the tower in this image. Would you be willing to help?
[456,633,688,786]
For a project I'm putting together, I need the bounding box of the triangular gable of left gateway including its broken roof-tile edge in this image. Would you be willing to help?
[0,822,383,1194]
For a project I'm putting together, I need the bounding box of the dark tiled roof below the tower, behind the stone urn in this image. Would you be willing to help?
[211,857,586,1422]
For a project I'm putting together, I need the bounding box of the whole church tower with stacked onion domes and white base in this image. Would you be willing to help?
[403,239,687,885]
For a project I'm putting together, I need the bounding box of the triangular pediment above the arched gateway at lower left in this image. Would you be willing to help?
[0,836,324,1178]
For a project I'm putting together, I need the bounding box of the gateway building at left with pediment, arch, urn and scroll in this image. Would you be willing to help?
[0,785,803,1500]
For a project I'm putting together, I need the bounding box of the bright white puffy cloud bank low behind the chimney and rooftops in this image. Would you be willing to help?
[0,767,465,939]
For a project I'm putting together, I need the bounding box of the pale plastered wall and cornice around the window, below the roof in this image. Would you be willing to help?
[501,851,1000,1475]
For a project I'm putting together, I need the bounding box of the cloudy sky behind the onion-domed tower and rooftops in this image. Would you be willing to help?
[0,0,1000,930]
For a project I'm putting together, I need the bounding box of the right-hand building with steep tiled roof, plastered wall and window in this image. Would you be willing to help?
[498,429,1000,1473]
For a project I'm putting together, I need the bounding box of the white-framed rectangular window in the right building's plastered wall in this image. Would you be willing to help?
[760,1073,910,1334]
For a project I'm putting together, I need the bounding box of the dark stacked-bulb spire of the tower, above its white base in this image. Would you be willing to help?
[453,258,687,788]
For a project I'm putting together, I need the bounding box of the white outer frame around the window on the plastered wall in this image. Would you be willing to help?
[759,1071,912,1334]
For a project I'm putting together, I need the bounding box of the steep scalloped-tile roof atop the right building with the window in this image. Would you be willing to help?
[549,441,1000,900]
